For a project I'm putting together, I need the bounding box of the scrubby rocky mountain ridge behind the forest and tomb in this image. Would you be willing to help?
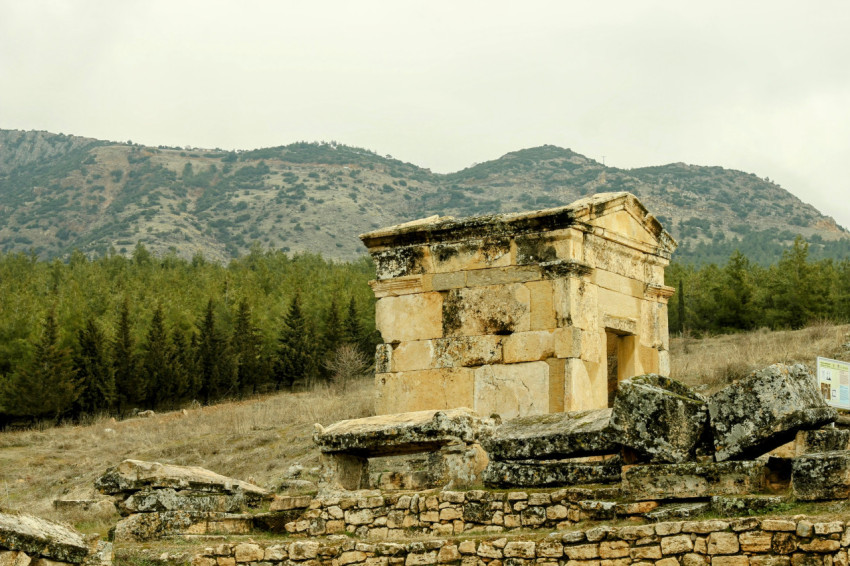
[0,130,850,261]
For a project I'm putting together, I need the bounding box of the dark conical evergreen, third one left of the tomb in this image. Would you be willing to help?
[275,294,316,389]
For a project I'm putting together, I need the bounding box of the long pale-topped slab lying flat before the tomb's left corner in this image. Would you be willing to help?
[313,408,492,458]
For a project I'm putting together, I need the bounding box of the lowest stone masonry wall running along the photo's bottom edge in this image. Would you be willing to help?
[192,517,850,566]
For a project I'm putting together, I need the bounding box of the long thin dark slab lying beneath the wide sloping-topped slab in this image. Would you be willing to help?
[483,457,623,488]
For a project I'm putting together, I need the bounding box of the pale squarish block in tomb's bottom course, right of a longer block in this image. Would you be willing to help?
[473,362,549,419]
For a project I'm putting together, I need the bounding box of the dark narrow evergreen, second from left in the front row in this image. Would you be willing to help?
[74,317,116,415]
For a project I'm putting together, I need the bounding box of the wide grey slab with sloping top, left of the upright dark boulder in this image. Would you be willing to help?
[483,409,620,460]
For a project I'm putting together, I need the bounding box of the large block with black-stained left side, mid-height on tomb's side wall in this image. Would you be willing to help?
[440,283,531,342]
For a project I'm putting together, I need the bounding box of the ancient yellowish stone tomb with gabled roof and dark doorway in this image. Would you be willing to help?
[361,193,676,418]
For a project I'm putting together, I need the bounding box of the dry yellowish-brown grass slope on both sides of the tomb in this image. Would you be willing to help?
[0,324,850,532]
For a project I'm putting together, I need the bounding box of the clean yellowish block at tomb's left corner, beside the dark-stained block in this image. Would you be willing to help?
[375,293,444,343]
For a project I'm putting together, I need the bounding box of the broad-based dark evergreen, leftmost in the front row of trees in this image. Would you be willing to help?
[3,308,80,420]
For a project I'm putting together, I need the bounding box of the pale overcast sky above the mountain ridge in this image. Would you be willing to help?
[0,0,850,231]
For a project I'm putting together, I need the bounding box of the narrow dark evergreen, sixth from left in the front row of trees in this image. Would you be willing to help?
[196,299,232,403]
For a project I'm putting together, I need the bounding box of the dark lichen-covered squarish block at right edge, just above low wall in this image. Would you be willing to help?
[791,450,850,501]
